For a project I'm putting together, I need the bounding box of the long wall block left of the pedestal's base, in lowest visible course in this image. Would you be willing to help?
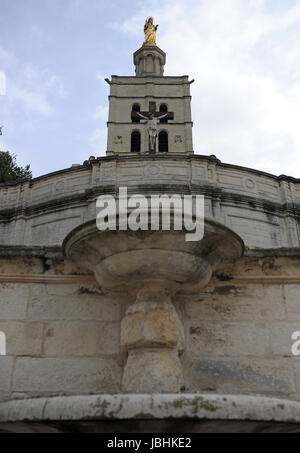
[13,357,121,396]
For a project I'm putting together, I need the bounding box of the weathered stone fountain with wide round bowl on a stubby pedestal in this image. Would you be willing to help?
[64,215,244,393]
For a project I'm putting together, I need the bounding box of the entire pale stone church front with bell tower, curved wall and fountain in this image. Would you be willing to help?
[0,23,300,432]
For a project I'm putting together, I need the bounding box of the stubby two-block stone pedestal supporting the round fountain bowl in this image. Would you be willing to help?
[121,290,184,393]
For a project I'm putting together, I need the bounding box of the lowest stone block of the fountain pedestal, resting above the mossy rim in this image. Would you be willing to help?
[122,348,184,393]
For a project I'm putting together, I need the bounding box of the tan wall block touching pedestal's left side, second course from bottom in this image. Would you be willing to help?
[44,321,120,357]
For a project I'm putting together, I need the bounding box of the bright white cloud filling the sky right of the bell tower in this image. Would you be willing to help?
[114,0,300,177]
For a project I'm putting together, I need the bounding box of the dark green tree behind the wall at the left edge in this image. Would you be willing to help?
[0,151,32,183]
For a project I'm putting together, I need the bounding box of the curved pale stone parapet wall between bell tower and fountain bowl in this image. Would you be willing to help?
[0,155,300,249]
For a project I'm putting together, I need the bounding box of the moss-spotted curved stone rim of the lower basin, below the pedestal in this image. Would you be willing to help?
[0,394,300,423]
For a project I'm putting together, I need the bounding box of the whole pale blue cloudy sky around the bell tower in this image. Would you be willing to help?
[0,0,300,178]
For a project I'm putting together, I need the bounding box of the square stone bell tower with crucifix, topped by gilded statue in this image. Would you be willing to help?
[106,18,194,156]
